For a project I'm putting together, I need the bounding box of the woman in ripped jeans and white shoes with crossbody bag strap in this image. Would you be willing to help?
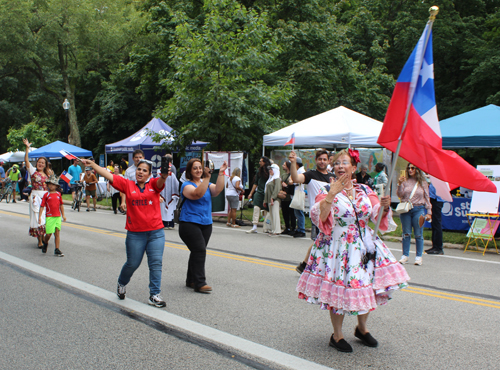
[397,163,432,266]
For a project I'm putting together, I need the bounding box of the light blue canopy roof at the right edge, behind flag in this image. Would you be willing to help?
[440,104,500,148]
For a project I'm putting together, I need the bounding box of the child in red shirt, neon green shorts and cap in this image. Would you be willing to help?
[39,175,66,257]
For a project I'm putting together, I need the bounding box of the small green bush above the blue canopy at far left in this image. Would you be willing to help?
[7,117,54,151]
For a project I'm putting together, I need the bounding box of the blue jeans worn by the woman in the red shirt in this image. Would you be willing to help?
[118,228,165,295]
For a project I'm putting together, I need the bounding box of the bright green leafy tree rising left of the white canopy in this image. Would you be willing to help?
[153,0,292,151]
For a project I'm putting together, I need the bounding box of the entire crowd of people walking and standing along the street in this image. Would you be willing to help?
[0,139,443,352]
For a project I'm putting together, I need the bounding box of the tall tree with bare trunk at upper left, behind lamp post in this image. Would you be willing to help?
[0,0,144,146]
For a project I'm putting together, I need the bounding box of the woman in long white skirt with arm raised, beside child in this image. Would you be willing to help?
[23,139,49,248]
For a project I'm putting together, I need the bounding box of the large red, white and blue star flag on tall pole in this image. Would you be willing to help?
[377,22,497,194]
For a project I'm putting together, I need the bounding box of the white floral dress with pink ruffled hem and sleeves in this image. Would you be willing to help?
[297,184,410,315]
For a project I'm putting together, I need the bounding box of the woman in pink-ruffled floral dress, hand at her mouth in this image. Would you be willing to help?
[297,149,410,352]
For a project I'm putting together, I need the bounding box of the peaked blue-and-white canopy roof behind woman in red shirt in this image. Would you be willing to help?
[106,118,208,154]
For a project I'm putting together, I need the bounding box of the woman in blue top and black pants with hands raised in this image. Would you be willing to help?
[179,158,227,293]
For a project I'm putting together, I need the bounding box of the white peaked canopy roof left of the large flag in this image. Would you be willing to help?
[264,106,382,148]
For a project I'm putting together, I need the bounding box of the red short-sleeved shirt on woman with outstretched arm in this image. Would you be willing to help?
[112,175,164,232]
